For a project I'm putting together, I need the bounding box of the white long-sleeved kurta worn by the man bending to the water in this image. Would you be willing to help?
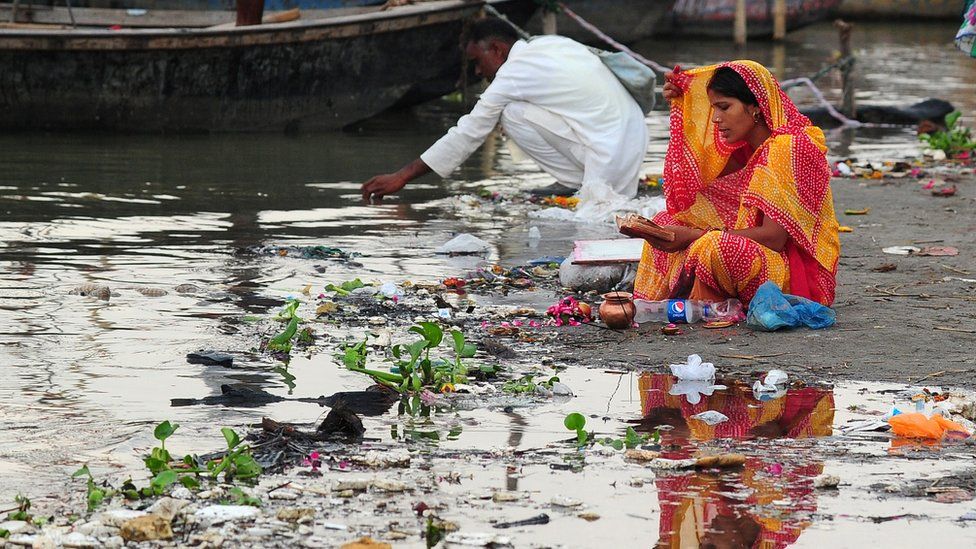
[420,36,648,197]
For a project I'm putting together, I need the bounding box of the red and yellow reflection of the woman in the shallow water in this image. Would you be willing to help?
[639,374,834,549]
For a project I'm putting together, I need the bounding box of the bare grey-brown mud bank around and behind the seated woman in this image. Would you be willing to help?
[556,174,976,388]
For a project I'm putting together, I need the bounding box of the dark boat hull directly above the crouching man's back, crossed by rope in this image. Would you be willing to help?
[527,0,674,45]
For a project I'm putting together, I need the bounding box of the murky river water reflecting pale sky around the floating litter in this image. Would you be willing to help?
[0,19,976,547]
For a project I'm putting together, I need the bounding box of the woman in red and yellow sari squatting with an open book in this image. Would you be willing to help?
[634,61,840,305]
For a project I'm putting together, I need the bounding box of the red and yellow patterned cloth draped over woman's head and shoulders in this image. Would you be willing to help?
[664,61,840,299]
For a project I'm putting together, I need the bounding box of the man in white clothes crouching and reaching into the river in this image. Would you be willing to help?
[362,18,647,200]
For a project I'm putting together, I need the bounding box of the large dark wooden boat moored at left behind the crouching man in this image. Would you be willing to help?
[0,0,536,132]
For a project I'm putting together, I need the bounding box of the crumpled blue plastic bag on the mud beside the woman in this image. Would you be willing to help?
[746,282,837,332]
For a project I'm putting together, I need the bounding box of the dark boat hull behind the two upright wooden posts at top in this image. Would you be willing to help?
[658,0,841,38]
